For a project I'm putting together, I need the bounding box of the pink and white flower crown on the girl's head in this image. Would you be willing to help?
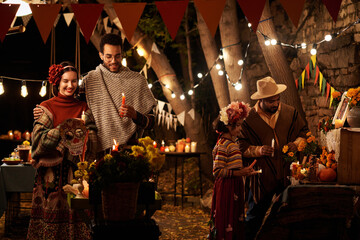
[220,102,250,125]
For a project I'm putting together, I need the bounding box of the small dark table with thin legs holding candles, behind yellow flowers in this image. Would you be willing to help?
[165,152,205,207]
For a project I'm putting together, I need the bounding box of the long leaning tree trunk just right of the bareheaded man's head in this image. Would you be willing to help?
[94,0,212,178]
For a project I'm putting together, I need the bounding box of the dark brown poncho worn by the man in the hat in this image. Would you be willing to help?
[239,103,308,201]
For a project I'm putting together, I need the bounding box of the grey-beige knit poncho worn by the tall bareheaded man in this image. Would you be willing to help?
[84,64,156,151]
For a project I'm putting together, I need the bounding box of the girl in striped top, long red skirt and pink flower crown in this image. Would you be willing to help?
[210,102,256,240]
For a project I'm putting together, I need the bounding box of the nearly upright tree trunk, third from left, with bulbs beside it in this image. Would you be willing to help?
[219,0,250,103]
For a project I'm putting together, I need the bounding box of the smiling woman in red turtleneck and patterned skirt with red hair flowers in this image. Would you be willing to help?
[27,62,96,240]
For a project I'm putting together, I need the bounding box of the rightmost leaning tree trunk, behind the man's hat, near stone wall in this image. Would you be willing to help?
[256,1,306,120]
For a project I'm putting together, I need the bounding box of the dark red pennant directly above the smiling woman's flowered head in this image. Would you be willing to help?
[29,4,61,43]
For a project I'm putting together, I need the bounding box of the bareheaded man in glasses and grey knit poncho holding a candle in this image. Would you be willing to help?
[84,34,156,152]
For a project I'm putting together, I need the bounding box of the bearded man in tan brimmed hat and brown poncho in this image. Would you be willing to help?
[239,77,308,239]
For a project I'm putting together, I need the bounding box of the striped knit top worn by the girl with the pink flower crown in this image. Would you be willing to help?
[213,137,243,178]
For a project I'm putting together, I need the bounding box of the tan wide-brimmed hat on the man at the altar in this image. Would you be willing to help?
[250,77,286,100]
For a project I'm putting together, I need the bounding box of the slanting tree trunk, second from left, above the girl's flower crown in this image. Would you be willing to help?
[195,7,230,108]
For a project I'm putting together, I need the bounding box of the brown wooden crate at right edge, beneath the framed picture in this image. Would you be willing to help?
[337,128,360,184]
